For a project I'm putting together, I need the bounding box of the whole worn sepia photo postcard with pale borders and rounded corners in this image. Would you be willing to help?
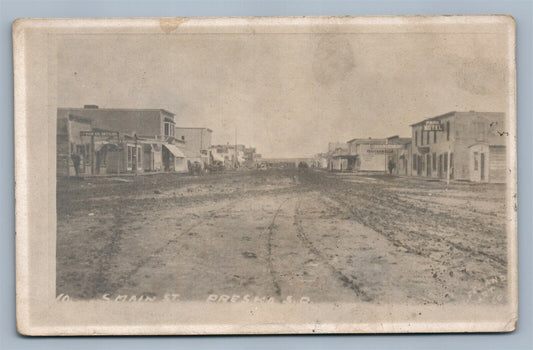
[13,15,518,335]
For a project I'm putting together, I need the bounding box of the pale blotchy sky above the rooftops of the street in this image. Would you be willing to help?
[57,34,509,157]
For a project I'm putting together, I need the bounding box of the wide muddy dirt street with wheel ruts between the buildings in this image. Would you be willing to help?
[57,169,507,304]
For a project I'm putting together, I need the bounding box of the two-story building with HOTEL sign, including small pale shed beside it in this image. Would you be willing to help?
[411,111,507,182]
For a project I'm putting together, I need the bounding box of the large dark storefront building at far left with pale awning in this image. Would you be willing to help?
[57,105,186,176]
